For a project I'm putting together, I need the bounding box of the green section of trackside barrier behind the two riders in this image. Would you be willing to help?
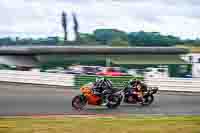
[75,76,143,89]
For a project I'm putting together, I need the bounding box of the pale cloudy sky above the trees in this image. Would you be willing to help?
[0,0,200,40]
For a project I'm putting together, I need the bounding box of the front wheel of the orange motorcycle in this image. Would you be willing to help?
[72,95,87,110]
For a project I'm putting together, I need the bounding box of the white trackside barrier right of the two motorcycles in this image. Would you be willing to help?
[144,78,200,92]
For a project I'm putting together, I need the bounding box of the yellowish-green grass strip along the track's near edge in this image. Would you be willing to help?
[0,116,200,133]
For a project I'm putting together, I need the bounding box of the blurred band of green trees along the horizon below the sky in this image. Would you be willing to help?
[0,29,200,46]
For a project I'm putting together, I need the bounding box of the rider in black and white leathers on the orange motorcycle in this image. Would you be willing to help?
[92,77,113,105]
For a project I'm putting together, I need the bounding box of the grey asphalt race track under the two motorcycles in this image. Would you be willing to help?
[0,82,200,116]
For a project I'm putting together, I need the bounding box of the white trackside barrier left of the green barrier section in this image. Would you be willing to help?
[0,70,74,87]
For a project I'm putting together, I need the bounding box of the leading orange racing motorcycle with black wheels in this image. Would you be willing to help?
[72,84,121,110]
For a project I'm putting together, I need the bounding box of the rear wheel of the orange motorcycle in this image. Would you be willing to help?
[106,95,121,109]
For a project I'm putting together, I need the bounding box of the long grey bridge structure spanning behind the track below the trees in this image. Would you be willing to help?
[0,46,189,67]
